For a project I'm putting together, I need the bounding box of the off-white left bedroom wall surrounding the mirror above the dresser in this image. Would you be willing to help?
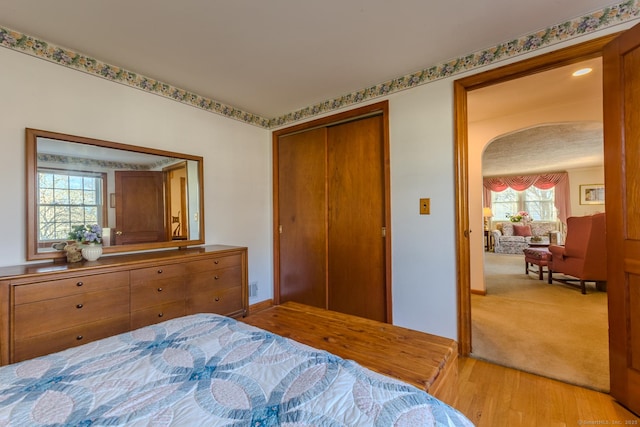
[0,49,273,303]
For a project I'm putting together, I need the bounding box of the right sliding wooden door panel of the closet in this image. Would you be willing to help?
[327,115,387,322]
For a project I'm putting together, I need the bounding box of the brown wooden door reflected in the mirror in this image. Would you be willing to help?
[112,171,169,245]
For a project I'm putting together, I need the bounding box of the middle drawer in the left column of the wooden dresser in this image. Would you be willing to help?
[13,286,129,339]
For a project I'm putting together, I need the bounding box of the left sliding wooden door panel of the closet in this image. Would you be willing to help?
[277,128,327,308]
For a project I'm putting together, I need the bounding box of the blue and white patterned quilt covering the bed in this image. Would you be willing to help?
[0,314,472,427]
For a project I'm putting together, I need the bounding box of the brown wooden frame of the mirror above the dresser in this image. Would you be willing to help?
[26,128,204,261]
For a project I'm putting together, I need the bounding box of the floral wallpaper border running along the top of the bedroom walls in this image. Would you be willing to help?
[0,0,640,129]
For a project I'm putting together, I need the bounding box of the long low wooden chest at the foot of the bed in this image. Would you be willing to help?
[242,301,458,407]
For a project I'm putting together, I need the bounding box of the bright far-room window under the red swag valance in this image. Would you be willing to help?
[491,185,558,221]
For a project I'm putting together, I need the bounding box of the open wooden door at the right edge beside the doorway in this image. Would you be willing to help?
[603,21,640,414]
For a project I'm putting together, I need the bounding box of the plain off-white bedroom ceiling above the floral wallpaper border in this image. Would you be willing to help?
[0,0,618,118]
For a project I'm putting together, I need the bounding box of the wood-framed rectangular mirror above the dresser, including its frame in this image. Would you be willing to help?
[26,129,204,260]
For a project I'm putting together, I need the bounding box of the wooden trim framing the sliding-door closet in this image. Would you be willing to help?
[272,100,393,323]
